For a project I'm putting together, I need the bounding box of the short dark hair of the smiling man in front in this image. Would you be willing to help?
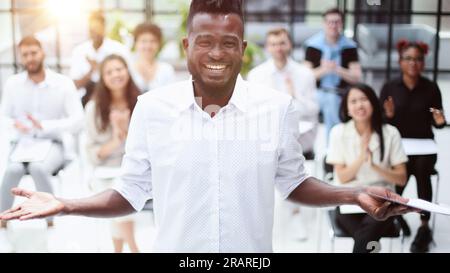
[187,0,244,30]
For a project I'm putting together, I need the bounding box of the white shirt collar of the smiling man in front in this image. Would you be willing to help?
[176,75,247,112]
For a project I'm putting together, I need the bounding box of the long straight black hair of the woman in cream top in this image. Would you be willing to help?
[339,83,384,161]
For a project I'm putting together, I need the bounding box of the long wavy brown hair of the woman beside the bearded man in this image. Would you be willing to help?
[94,54,140,131]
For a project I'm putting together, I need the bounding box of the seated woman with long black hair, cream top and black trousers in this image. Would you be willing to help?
[327,84,408,253]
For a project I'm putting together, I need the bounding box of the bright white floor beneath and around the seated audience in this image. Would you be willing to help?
[0,77,450,253]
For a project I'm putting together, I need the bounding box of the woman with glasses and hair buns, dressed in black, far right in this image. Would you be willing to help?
[380,40,446,252]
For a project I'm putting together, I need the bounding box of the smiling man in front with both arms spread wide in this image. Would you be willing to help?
[0,0,416,252]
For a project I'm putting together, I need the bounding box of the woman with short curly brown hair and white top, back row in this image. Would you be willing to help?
[131,23,175,93]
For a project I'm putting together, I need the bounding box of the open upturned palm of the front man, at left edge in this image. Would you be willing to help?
[0,188,64,221]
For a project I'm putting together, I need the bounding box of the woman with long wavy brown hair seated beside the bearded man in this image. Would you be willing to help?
[86,55,140,252]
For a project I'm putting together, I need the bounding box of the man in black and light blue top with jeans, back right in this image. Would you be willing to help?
[305,8,362,140]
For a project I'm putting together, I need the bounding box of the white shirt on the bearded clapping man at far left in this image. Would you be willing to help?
[1,69,84,140]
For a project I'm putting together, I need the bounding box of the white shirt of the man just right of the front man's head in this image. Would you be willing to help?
[248,59,320,152]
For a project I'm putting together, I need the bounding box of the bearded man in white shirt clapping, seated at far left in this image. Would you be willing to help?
[0,37,83,225]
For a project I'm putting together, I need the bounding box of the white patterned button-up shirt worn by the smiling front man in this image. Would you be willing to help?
[116,77,308,252]
